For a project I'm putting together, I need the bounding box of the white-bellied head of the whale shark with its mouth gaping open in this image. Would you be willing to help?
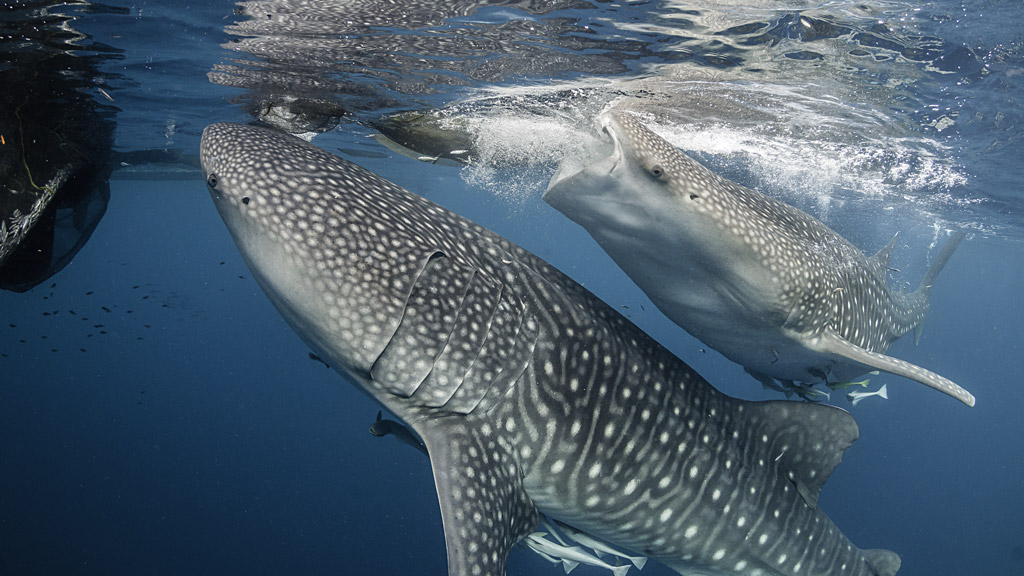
[544,112,788,339]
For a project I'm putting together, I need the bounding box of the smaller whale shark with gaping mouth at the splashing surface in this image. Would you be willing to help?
[544,112,975,406]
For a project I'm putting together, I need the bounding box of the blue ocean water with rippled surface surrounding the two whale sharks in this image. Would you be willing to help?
[0,0,1024,576]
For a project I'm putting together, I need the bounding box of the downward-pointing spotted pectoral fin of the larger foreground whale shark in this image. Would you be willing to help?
[416,416,539,576]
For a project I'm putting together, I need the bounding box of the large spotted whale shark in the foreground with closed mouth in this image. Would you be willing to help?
[201,124,900,576]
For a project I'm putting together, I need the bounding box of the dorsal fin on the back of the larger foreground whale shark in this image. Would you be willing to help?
[743,401,860,508]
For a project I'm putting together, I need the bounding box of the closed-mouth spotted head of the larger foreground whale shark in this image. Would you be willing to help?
[201,124,432,374]
